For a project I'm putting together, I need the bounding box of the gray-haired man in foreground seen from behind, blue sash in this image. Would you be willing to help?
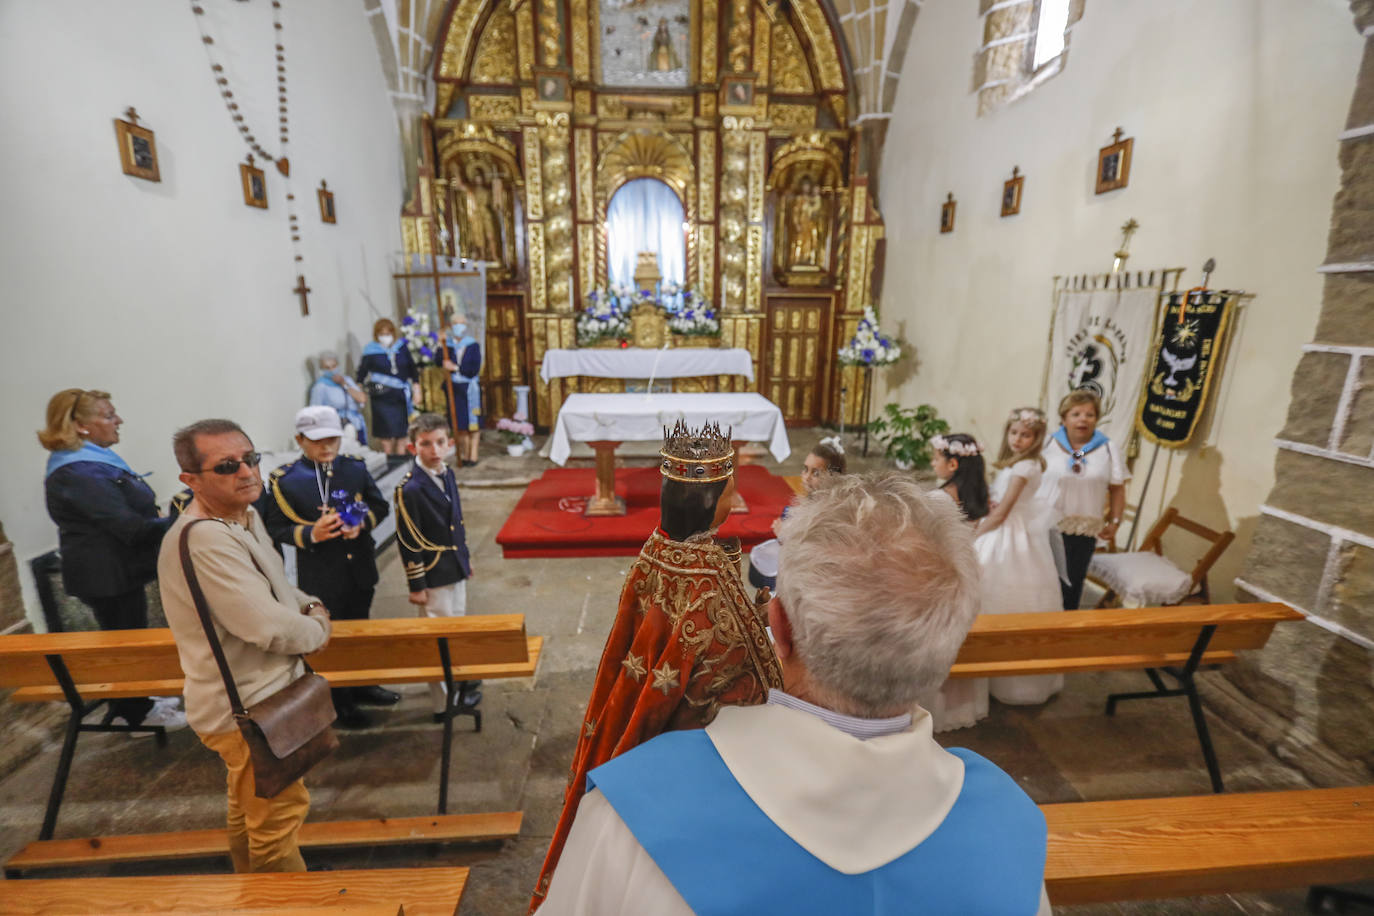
[540,474,1050,916]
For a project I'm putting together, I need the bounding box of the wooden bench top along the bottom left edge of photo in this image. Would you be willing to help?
[0,868,467,916]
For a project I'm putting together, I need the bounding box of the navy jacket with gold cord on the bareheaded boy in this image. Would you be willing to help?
[396,464,473,592]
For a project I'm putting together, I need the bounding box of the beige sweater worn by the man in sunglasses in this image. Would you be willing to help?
[158,508,330,735]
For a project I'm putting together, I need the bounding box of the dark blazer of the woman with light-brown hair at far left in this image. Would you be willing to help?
[44,461,172,597]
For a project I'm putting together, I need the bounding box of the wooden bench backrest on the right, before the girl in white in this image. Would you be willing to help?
[956,603,1303,663]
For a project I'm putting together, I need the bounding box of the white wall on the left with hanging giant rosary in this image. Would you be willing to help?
[0,0,401,619]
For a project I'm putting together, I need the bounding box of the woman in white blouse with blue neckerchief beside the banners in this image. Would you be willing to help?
[1041,390,1131,611]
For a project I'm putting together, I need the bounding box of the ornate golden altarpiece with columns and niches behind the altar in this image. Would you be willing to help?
[403,0,882,426]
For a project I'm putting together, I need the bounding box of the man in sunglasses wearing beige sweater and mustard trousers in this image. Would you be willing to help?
[158,420,330,872]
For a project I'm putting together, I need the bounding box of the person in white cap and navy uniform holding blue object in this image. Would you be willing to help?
[262,407,401,728]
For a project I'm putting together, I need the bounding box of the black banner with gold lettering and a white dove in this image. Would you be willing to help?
[1138,290,1234,449]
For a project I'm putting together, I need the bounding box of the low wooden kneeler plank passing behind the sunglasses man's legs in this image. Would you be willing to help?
[4,812,523,878]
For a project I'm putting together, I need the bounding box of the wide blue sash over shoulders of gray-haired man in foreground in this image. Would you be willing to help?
[587,729,1047,916]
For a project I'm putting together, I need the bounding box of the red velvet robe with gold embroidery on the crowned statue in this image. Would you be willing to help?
[530,531,782,912]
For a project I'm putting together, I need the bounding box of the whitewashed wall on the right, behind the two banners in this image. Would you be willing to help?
[875,0,1362,597]
